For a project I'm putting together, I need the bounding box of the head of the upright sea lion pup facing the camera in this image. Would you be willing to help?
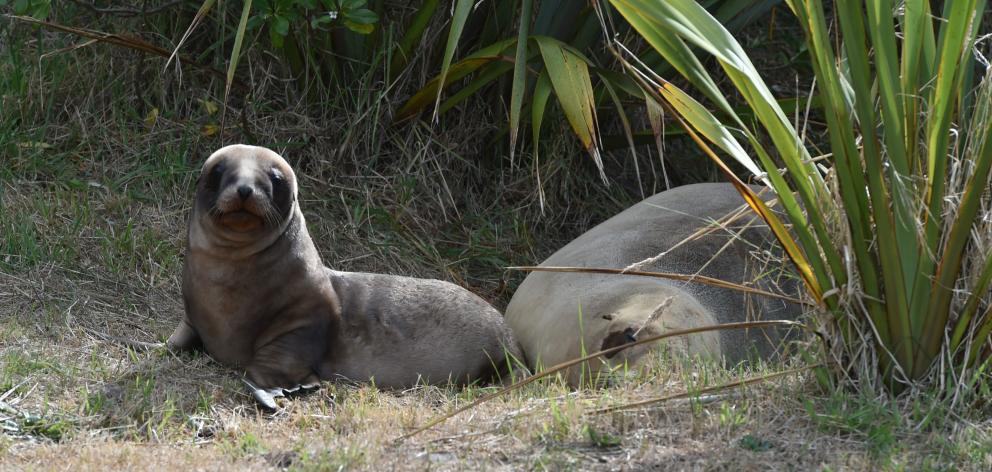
[190,144,297,248]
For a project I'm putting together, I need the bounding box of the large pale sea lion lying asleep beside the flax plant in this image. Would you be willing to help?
[506,184,801,385]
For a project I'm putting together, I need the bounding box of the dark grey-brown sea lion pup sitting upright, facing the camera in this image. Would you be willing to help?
[167,145,520,409]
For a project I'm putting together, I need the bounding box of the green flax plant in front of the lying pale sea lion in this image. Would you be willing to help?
[598,0,992,392]
